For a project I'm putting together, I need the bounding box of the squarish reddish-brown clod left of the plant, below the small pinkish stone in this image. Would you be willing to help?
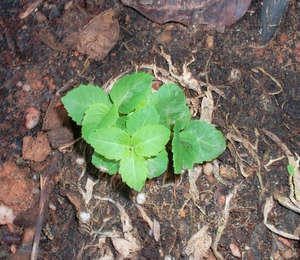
[22,132,51,162]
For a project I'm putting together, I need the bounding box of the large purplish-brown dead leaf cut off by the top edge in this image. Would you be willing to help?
[122,0,251,32]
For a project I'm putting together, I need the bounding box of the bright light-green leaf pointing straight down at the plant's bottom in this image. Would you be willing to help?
[120,151,148,191]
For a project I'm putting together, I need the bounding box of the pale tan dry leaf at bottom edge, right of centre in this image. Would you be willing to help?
[184,225,212,260]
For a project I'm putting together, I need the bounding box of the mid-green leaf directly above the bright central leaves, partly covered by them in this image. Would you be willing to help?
[126,106,159,134]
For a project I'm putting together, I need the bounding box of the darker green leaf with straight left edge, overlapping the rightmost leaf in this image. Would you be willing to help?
[172,132,199,174]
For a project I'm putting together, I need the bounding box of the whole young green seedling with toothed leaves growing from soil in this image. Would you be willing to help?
[62,72,226,191]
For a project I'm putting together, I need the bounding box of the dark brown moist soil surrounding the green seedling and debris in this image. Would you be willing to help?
[0,0,300,260]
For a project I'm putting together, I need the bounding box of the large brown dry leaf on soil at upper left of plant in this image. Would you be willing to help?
[64,10,120,61]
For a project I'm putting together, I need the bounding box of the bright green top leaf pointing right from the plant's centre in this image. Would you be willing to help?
[132,125,170,157]
